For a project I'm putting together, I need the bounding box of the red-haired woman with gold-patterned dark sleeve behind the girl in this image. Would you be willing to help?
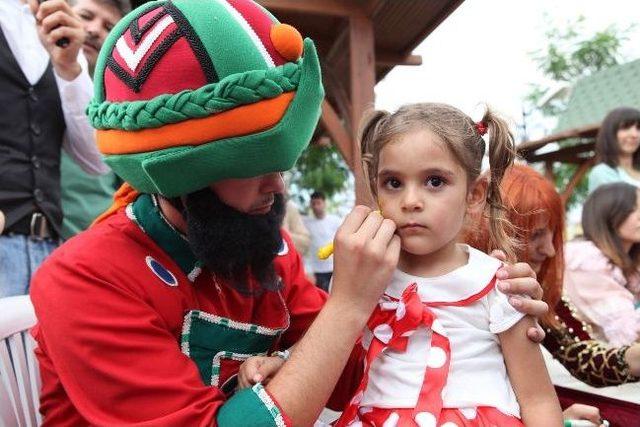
[465,165,640,387]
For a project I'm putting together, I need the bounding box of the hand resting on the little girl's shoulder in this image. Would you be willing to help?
[491,250,549,343]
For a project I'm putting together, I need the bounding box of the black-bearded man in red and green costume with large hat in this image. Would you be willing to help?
[31,0,544,426]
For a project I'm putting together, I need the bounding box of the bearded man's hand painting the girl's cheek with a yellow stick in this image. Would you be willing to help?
[331,206,400,317]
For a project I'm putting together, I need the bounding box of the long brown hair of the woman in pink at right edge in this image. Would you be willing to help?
[582,182,640,280]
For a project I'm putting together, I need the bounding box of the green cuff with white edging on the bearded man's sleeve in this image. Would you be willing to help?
[217,383,289,427]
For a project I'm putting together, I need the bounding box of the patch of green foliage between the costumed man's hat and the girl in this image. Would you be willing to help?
[290,144,351,202]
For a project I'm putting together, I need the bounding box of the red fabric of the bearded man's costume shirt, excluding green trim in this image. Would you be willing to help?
[31,210,327,426]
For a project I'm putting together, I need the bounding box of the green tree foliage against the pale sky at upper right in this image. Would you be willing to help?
[526,17,631,208]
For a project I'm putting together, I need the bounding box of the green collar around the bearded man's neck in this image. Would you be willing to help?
[127,194,202,282]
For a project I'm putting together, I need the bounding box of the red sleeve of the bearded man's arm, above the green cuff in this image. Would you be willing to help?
[31,262,224,426]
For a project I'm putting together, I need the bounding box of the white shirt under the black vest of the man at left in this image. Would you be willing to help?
[0,0,110,175]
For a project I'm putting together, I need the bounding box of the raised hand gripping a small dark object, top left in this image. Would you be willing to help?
[29,0,85,81]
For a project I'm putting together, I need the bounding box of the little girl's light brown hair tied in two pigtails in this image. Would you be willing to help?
[360,103,515,260]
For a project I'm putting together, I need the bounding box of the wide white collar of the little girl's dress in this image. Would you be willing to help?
[385,244,502,302]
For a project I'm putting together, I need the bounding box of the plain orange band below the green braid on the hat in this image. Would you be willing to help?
[96,92,295,155]
